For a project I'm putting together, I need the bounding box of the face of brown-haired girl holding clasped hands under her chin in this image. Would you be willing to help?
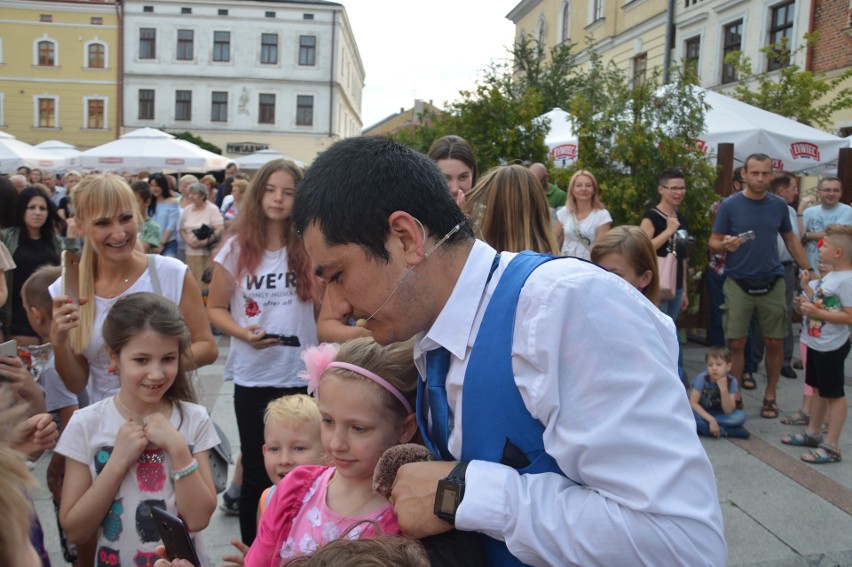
[109,329,180,411]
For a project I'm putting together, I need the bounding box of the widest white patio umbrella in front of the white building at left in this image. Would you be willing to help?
[80,128,228,172]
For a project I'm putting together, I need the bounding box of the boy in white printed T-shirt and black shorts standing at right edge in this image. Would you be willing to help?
[781,224,852,465]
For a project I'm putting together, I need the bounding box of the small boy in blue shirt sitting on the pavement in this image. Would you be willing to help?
[689,346,749,439]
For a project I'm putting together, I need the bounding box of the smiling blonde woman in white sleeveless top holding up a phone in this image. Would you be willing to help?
[50,174,219,403]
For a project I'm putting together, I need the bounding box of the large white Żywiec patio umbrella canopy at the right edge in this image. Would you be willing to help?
[693,87,849,172]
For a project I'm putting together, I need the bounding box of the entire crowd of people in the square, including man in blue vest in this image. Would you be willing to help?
[0,136,852,567]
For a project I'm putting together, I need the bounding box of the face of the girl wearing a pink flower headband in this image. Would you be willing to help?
[318,372,414,481]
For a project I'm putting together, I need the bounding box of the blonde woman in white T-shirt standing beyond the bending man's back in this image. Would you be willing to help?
[556,169,612,260]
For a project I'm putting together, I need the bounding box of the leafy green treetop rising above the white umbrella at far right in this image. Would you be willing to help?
[725,34,852,130]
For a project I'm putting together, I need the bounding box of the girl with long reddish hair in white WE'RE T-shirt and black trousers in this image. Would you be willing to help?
[207,160,319,543]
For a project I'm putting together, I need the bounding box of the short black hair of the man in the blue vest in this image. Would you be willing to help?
[291,136,473,262]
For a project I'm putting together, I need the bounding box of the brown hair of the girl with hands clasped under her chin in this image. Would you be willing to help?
[103,291,195,409]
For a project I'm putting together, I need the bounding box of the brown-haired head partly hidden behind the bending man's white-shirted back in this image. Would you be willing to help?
[591,226,660,305]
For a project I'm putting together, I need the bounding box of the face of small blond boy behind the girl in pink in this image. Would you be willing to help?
[263,418,325,484]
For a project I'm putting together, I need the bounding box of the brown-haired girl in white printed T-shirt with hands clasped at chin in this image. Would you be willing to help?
[56,292,219,565]
